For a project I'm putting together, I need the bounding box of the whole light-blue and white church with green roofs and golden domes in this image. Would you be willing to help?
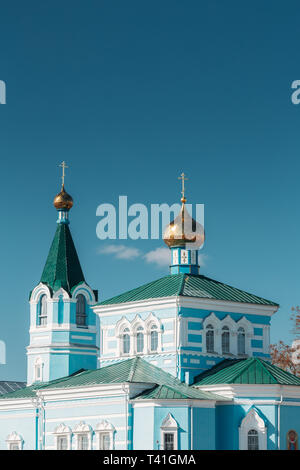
[0,170,300,450]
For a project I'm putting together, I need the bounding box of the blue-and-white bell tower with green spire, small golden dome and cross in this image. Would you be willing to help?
[27,162,99,385]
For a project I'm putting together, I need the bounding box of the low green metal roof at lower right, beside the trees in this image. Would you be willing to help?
[194,357,300,385]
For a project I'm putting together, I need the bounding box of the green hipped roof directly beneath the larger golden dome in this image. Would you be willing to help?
[98,273,278,307]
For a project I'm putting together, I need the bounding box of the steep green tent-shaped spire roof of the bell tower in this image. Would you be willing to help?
[41,224,85,292]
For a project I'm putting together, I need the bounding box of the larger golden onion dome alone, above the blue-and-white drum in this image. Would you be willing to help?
[163,197,204,249]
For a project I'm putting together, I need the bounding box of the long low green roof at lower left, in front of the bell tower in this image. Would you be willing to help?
[1,357,223,400]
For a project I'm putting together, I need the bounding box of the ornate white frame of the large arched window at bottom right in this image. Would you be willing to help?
[239,408,267,450]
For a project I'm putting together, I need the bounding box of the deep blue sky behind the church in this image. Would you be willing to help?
[0,0,300,379]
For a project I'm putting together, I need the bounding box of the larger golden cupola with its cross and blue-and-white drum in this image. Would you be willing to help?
[163,173,205,274]
